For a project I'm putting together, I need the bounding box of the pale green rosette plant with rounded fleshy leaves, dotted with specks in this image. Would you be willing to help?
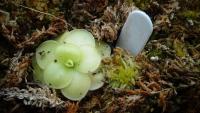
[32,29,111,101]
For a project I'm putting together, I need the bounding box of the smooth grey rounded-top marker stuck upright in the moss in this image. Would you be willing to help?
[117,10,153,56]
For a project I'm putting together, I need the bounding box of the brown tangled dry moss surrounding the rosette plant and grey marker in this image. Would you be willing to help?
[0,0,200,113]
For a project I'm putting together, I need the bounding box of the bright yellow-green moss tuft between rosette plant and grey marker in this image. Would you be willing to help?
[104,48,139,89]
